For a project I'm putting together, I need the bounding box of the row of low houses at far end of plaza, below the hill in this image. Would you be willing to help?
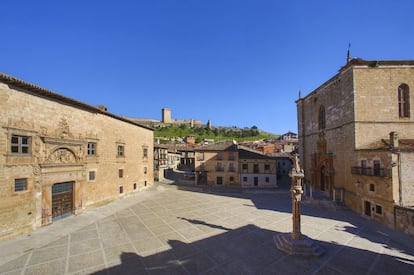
[154,141,292,188]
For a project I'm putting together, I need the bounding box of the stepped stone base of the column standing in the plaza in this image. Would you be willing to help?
[273,233,325,257]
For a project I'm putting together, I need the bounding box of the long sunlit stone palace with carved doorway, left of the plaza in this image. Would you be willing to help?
[0,74,154,239]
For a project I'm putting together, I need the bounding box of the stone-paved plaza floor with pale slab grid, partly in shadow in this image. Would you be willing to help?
[0,185,414,274]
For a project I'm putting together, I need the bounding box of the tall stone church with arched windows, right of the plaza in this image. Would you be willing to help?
[296,59,414,234]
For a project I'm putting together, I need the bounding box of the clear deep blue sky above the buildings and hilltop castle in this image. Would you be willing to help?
[0,0,414,134]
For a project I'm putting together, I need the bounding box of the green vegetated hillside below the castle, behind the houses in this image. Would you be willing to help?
[154,124,278,143]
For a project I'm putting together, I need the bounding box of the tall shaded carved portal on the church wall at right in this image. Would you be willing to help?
[311,132,335,194]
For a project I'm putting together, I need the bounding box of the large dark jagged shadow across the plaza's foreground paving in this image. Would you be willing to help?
[94,224,414,274]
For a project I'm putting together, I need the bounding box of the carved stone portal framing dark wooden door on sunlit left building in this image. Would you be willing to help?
[37,118,87,225]
